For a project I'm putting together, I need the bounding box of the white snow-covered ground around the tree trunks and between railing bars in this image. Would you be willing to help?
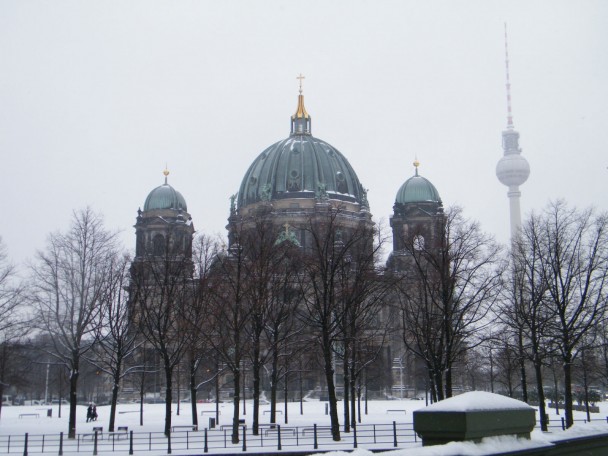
[0,399,608,456]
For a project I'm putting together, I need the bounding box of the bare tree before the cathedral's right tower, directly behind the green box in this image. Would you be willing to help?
[399,207,502,400]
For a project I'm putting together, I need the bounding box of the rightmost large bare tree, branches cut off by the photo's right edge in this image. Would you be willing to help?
[538,201,608,427]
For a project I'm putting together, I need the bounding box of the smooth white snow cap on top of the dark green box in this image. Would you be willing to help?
[423,391,531,412]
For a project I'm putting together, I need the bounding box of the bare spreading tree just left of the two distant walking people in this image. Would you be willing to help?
[32,208,117,438]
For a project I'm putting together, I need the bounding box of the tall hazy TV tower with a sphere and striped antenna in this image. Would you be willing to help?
[496,23,530,240]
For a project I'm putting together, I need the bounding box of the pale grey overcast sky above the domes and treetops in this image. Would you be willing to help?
[0,0,608,263]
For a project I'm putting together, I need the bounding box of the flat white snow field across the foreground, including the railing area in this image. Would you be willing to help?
[0,393,608,456]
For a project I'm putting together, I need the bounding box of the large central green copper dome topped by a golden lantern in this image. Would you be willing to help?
[238,95,367,209]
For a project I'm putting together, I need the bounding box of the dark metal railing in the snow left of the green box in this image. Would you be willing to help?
[0,421,419,456]
